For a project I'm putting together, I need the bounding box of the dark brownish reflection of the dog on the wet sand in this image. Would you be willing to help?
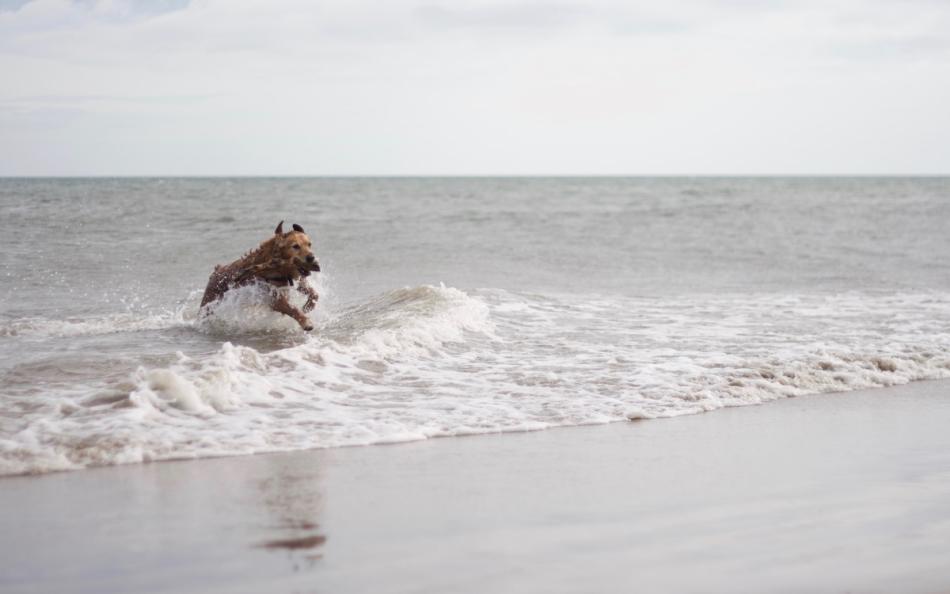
[254,460,327,569]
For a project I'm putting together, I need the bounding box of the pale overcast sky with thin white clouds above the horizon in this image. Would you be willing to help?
[0,0,950,176]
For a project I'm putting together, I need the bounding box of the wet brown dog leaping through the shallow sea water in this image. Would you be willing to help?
[201,221,320,331]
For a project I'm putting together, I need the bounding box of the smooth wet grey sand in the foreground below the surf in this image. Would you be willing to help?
[0,381,950,594]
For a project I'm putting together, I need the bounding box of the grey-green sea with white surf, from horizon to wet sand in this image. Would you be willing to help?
[0,178,950,474]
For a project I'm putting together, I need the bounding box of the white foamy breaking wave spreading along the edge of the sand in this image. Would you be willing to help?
[0,286,950,474]
